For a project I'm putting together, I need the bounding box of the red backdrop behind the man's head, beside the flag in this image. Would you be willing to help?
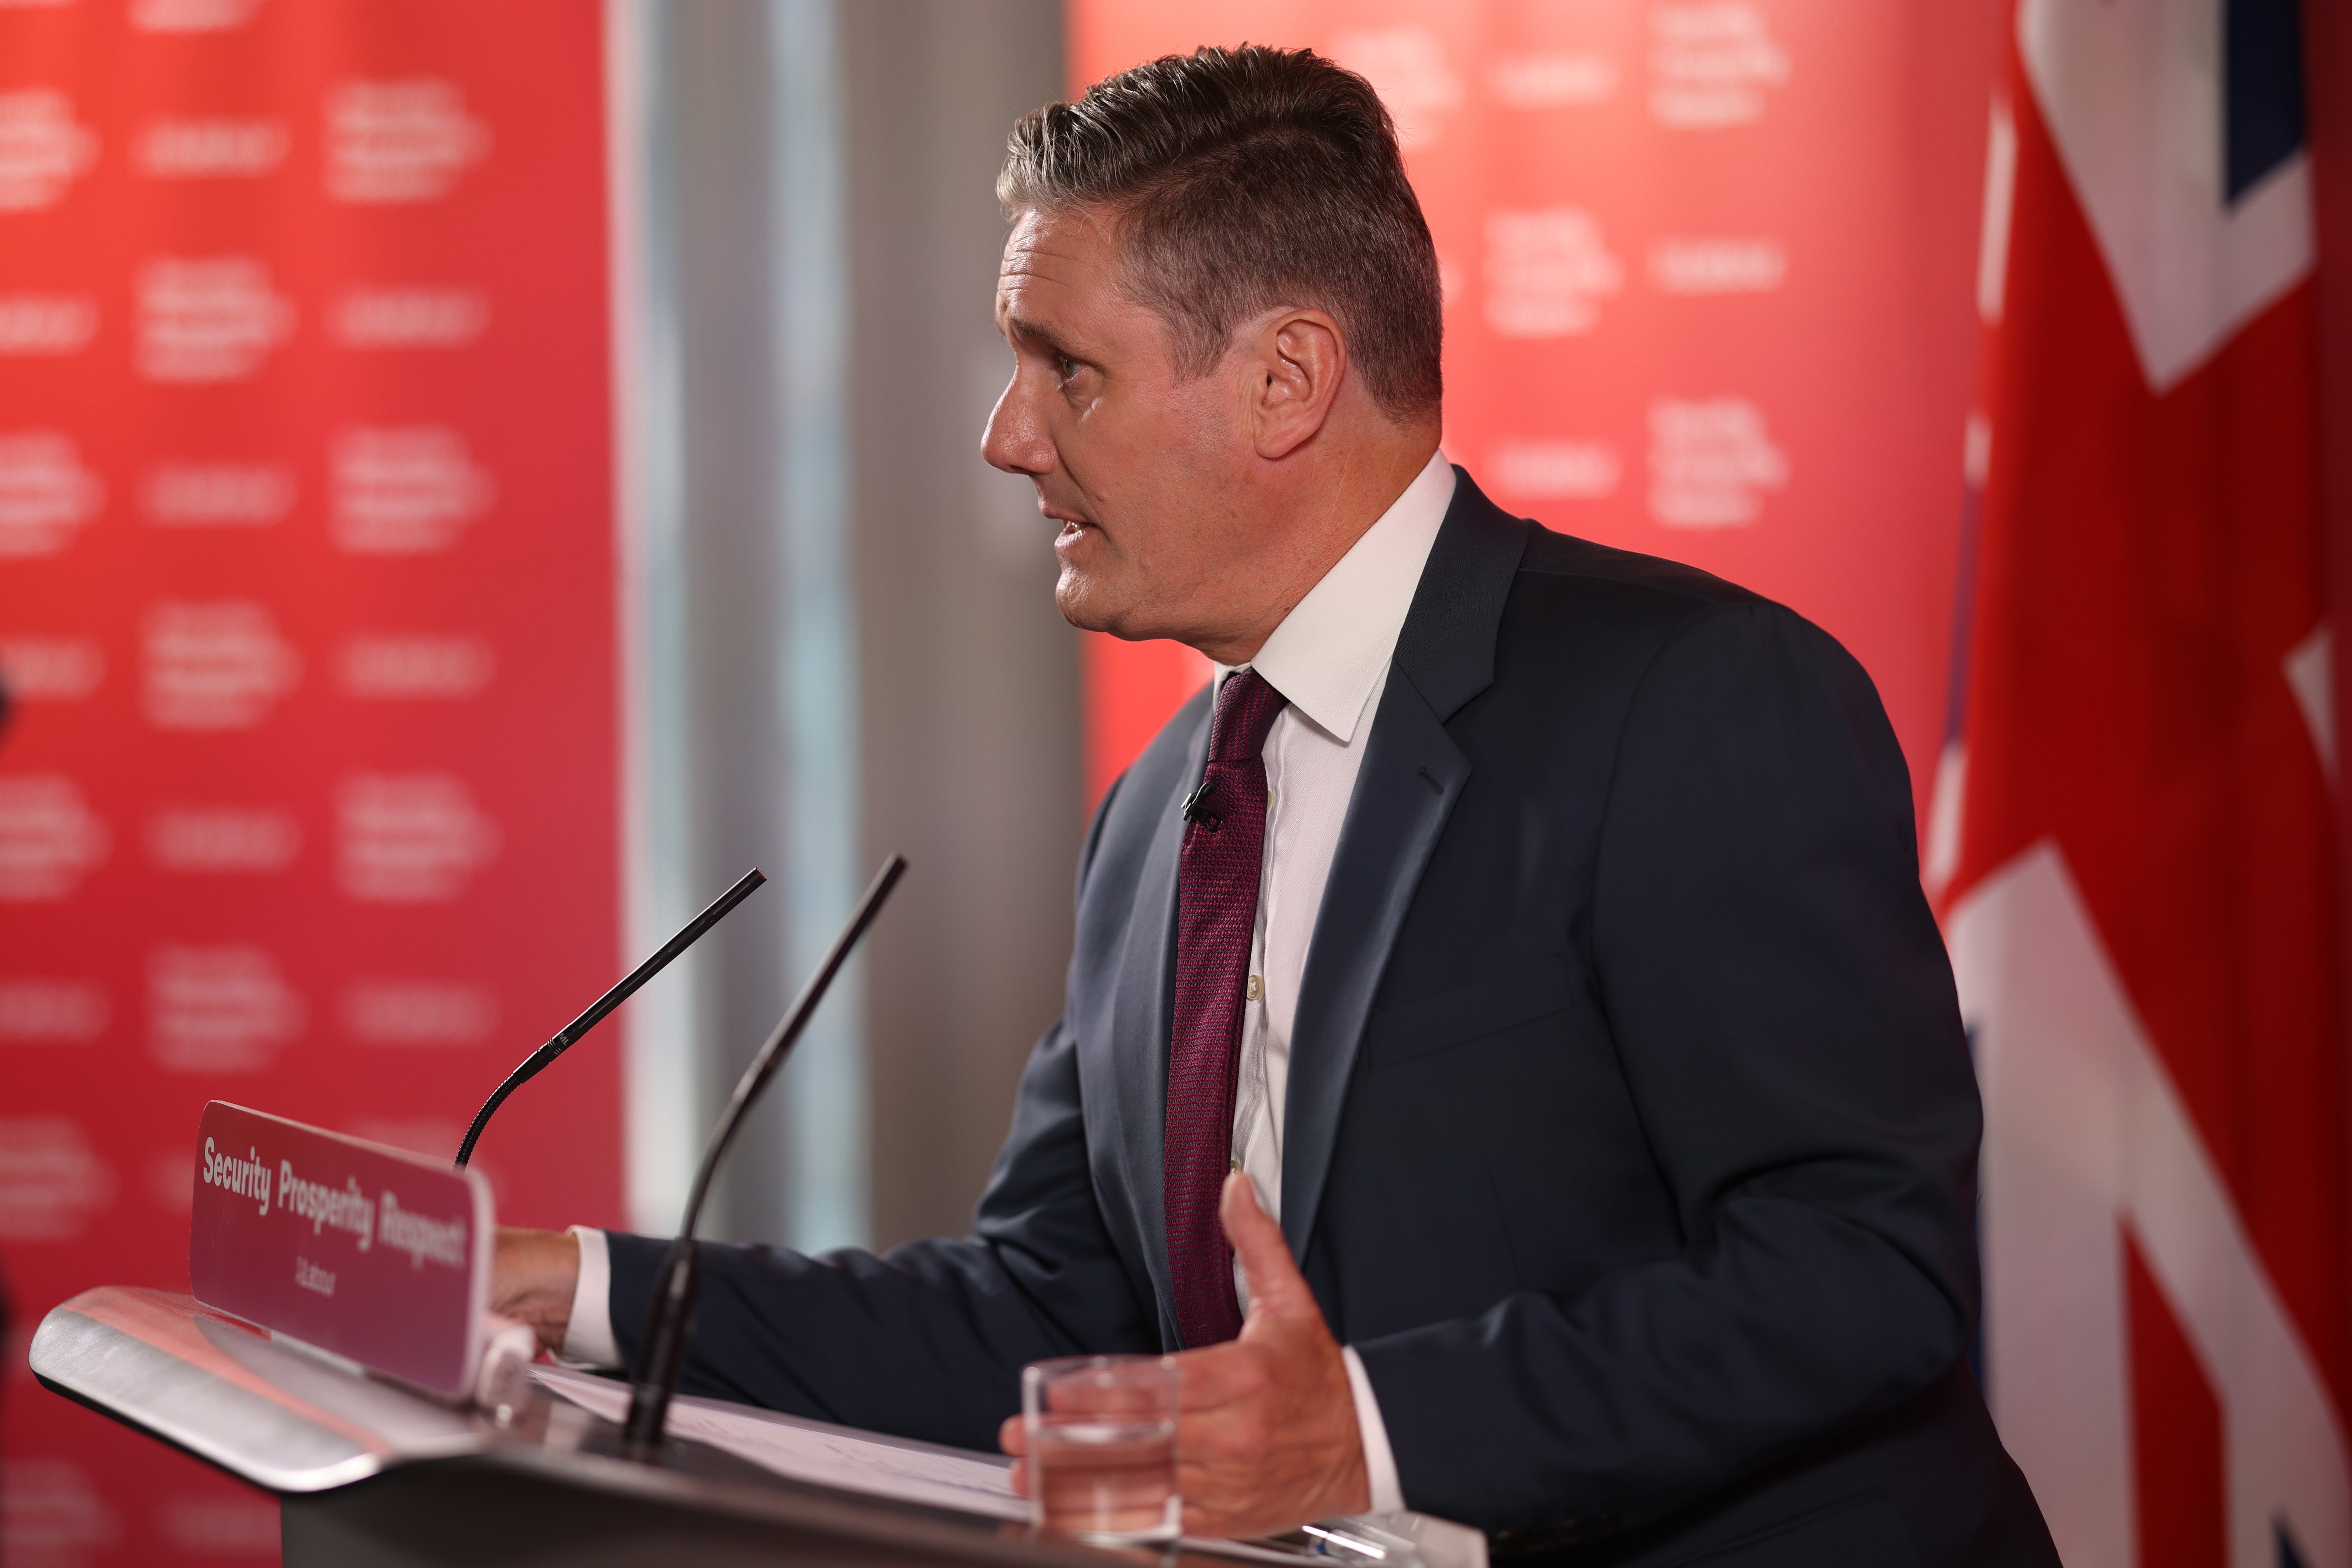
[1070,0,2006,816]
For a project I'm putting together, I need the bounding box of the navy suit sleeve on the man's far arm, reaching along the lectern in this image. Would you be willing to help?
[611,780,1160,1448]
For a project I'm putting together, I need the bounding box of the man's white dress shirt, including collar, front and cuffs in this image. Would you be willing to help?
[565,454,1454,1514]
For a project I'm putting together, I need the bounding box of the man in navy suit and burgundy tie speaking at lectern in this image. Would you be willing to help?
[499,49,2056,1566]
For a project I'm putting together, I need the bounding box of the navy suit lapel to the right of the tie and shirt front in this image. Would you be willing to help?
[1289,468,1529,1258]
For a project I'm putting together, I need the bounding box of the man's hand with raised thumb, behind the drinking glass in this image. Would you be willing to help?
[1000,1171,1371,1535]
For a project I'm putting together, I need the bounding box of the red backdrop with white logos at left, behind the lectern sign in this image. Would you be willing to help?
[0,0,621,1566]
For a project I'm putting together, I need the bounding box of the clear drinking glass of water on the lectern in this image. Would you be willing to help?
[1021,1356,1183,1545]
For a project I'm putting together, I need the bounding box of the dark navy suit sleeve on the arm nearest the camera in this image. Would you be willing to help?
[1357,602,1981,1533]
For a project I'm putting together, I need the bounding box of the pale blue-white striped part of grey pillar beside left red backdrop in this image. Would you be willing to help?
[616,0,866,1246]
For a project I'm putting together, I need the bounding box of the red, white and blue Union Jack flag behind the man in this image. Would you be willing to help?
[1926,0,2352,1568]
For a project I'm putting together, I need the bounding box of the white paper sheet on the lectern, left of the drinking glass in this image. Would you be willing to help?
[532,1366,1030,1519]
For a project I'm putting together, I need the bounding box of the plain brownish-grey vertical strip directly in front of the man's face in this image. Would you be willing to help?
[840,0,1084,1244]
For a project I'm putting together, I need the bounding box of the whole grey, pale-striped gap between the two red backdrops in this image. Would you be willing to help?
[616,0,1084,1246]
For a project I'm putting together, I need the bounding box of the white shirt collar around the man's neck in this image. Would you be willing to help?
[1216,451,1454,745]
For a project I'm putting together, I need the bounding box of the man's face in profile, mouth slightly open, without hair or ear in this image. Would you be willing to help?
[981,212,1261,642]
